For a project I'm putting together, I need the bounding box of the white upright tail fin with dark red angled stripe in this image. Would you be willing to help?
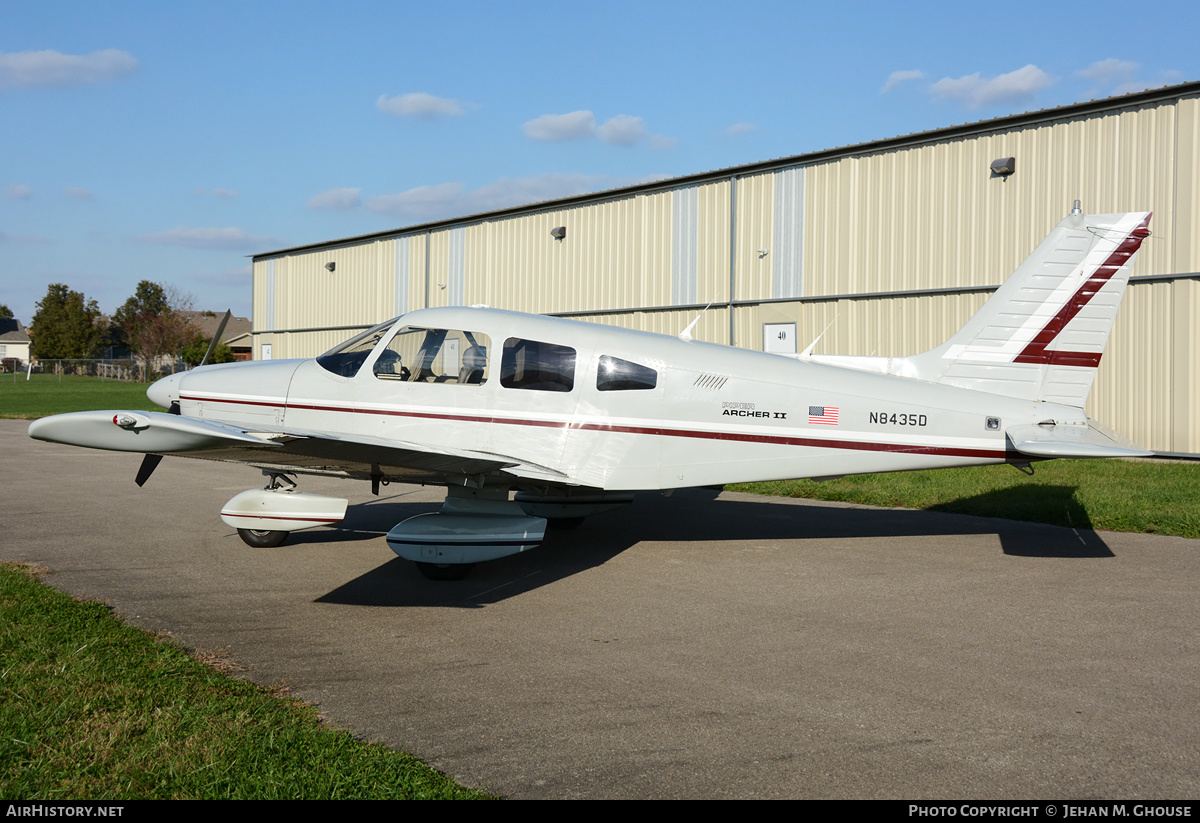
[902,208,1151,407]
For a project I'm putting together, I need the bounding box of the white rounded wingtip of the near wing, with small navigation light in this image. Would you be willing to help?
[29,409,280,455]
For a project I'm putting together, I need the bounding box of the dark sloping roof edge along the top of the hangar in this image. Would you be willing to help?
[251,82,1200,259]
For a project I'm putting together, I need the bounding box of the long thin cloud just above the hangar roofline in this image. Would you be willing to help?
[366,174,643,222]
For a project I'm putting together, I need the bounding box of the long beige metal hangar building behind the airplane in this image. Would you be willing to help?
[253,83,1200,456]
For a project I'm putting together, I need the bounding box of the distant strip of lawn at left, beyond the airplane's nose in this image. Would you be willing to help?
[0,374,162,420]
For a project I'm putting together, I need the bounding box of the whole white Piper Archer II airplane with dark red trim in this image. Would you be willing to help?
[29,202,1151,579]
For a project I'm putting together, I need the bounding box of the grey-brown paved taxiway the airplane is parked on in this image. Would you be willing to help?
[0,420,1200,799]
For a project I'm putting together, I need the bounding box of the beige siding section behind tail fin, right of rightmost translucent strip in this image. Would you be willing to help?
[805,101,1180,296]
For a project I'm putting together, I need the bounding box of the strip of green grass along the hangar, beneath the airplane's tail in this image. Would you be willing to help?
[730,459,1200,537]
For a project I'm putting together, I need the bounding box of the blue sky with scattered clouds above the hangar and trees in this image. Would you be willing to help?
[0,0,1200,324]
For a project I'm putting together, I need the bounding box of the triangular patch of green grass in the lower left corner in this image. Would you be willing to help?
[0,564,488,800]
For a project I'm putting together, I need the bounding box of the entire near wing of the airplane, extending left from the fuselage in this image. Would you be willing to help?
[29,410,568,482]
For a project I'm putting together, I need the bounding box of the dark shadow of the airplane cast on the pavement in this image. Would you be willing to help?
[314,487,1112,608]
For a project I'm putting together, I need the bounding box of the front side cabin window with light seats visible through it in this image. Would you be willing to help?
[374,326,492,386]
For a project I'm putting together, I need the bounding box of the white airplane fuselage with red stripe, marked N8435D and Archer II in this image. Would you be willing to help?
[162,308,1086,491]
